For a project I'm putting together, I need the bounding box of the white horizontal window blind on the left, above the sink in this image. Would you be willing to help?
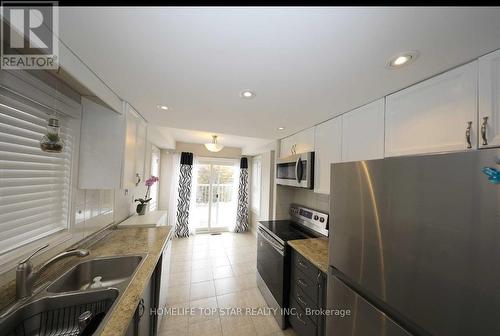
[0,87,74,254]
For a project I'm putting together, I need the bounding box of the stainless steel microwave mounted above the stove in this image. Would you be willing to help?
[276,152,314,189]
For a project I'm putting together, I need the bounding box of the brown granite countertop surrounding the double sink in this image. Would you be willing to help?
[0,226,173,336]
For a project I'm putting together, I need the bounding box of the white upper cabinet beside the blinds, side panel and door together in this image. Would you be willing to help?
[78,98,147,189]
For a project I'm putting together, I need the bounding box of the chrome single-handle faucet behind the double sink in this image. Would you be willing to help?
[16,244,90,300]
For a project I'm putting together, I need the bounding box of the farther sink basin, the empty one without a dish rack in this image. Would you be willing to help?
[47,256,143,293]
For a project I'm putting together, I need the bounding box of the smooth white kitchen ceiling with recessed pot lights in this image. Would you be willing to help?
[60,7,500,140]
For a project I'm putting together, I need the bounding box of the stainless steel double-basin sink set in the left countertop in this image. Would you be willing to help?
[0,255,144,336]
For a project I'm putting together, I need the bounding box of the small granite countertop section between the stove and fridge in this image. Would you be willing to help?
[287,238,328,273]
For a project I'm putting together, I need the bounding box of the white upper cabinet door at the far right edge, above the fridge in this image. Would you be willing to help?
[479,50,500,147]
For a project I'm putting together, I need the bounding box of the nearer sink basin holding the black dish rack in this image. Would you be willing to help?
[0,288,119,336]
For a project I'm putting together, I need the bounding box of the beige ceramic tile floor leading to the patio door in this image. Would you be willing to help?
[159,233,295,336]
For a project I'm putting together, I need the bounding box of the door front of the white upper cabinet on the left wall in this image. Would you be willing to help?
[123,104,147,188]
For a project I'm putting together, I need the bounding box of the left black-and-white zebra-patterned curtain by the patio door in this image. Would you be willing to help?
[175,152,193,237]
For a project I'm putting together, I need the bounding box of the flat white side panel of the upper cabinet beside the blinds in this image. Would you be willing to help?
[78,97,125,189]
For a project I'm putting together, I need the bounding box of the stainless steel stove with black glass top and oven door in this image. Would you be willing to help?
[257,204,328,329]
